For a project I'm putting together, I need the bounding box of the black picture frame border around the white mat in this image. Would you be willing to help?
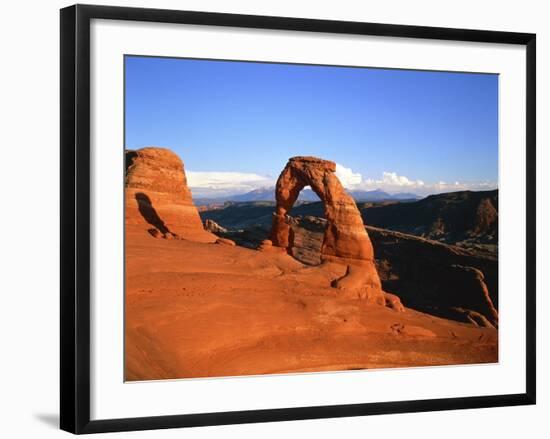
[60,5,536,434]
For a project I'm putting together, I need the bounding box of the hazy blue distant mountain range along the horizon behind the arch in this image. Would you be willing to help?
[191,187,422,206]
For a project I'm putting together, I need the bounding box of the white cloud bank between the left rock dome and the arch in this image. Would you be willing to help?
[185,171,275,197]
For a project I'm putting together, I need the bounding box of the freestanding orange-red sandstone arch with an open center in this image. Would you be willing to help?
[271,157,385,304]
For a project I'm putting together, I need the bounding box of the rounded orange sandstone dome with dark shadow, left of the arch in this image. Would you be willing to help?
[125,147,217,242]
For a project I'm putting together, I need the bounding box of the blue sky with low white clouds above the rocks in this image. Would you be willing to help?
[125,56,498,196]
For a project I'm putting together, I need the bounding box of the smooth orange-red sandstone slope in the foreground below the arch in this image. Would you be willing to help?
[125,230,498,381]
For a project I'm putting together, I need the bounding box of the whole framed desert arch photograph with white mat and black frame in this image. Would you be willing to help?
[61,5,536,433]
